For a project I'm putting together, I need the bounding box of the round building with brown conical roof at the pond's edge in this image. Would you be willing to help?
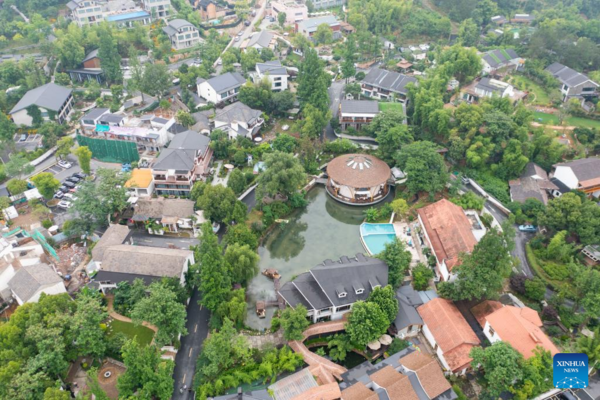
[327,154,392,206]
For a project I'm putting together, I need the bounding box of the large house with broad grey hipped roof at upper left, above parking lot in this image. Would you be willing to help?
[9,83,73,126]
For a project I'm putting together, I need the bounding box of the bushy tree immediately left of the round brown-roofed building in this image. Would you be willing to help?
[257,151,306,199]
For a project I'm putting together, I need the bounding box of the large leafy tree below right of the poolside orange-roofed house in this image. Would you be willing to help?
[439,224,515,301]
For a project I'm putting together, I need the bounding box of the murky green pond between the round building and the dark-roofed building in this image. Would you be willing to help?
[246,186,366,330]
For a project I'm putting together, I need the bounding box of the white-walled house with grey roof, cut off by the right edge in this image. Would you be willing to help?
[553,157,600,198]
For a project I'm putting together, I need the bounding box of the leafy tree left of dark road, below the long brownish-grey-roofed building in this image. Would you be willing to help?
[131,282,187,346]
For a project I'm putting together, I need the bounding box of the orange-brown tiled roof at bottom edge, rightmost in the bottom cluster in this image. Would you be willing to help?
[399,351,452,399]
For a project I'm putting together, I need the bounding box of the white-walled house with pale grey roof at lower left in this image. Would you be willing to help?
[8,263,67,305]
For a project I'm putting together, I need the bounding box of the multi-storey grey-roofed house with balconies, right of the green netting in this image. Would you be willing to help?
[151,130,213,196]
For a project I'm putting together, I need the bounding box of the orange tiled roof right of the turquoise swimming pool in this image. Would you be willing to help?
[417,199,477,271]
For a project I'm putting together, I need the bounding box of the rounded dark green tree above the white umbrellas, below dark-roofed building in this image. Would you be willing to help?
[346,301,390,347]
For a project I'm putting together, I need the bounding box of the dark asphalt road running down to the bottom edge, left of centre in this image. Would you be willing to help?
[172,289,210,400]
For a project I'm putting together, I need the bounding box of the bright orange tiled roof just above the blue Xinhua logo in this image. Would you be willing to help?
[486,306,559,358]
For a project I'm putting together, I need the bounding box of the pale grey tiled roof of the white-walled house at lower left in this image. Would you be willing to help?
[8,264,62,303]
